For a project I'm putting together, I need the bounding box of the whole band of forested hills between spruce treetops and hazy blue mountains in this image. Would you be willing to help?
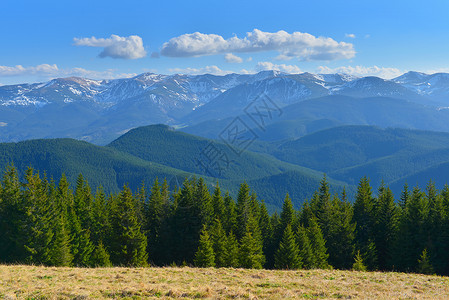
[0,125,449,211]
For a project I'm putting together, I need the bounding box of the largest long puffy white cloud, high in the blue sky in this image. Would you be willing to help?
[161,29,355,60]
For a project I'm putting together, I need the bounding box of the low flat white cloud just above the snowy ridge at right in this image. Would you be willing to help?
[318,66,404,79]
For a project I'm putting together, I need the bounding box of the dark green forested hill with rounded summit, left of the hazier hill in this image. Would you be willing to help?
[0,125,346,211]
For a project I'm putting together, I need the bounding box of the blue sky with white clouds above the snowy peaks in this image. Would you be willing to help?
[0,0,449,84]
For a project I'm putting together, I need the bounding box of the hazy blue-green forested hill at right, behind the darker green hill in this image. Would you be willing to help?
[272,126,449,186]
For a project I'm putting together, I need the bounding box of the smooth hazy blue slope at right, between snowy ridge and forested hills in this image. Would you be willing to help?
[181,95,449,141]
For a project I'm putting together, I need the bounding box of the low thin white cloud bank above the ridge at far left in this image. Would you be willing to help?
[0,64,136,79]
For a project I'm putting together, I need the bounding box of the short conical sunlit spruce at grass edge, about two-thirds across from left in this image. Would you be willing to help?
[274,224,301,270]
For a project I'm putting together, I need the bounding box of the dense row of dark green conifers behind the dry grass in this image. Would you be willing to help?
[0,166,449,275]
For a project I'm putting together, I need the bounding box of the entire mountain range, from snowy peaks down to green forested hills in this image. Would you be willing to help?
[0,71,449,211]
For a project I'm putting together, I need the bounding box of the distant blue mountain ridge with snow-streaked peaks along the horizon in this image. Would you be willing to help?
[0,71,449,144]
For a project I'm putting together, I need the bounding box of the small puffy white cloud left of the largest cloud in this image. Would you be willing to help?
[73,34,147,59]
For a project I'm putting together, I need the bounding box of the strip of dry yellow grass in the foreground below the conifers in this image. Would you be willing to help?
[0,266,449,299]
